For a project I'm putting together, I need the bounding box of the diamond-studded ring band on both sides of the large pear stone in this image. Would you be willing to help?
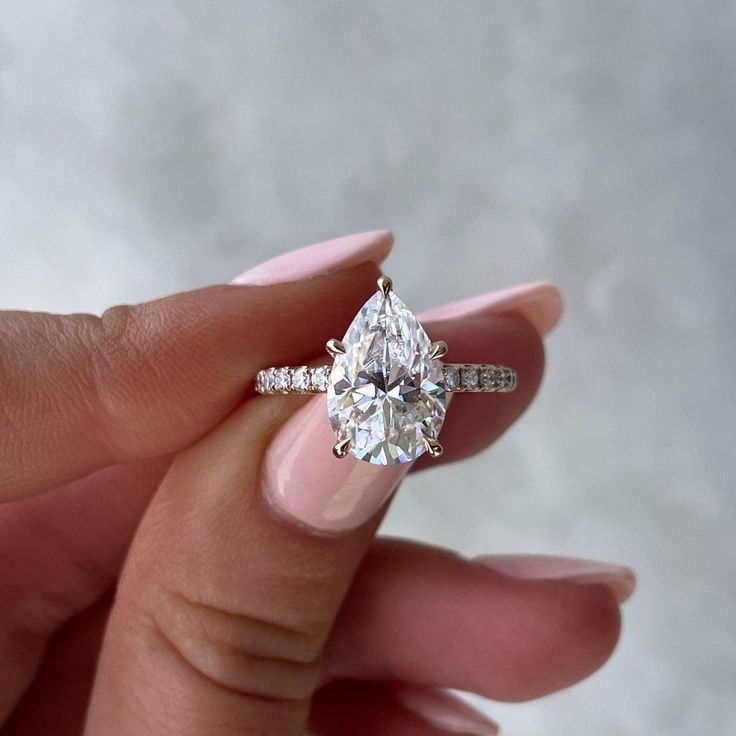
[256,363,517,395]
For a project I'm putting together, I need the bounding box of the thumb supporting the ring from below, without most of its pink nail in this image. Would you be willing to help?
[86,382,406,736]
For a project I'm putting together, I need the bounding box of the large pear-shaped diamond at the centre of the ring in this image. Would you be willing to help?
[327,290,445,465]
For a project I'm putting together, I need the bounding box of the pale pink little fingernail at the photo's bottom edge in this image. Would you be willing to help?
[393,685,499,736]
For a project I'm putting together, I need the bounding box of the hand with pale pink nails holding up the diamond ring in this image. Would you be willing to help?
[0,233,633,736]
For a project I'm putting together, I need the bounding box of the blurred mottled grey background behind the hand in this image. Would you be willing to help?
[0,0,736,736]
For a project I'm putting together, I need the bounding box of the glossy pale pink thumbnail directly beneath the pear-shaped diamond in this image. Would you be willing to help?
[262,396,411,534]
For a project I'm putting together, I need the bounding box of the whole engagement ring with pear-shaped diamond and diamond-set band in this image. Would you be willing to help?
[256,276,516,465]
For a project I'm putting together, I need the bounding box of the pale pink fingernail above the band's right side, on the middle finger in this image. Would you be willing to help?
[421,281,563,336]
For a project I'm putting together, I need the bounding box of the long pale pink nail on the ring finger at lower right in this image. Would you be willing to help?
[474,555,636,603]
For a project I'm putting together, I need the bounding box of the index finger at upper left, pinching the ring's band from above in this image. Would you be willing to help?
[0,232,392,501]
